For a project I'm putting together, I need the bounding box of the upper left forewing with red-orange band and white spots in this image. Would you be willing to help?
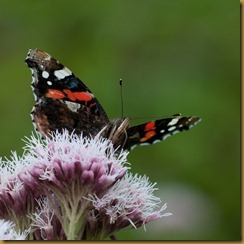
[25,49,108,120]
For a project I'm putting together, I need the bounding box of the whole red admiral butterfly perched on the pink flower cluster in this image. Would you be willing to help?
[25,49,200,150]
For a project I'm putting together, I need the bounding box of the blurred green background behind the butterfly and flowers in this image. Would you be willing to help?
[0,0,241,240]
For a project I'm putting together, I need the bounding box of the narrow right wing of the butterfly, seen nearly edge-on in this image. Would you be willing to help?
[123,115,201,150]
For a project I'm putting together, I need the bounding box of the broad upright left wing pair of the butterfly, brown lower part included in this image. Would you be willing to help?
[25,49,110,137]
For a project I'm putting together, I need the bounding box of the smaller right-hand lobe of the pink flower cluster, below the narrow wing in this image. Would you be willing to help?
[88,173,172,239]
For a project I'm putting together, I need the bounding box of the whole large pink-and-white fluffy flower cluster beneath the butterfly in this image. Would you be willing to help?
[0,131,171,240]
